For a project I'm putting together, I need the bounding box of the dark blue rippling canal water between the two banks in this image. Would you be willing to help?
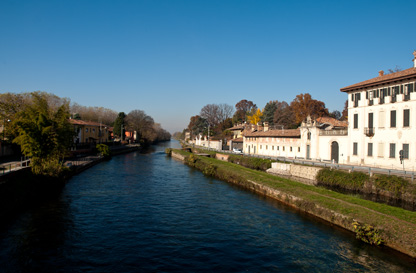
[0,142,415,272]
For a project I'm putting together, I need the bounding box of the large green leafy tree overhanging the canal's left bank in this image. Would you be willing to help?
[13,92,74,176]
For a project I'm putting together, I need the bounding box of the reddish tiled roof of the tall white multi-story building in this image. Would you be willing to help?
[341,67,416,92]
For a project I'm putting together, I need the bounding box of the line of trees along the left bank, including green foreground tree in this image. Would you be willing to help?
[0,91,170,176]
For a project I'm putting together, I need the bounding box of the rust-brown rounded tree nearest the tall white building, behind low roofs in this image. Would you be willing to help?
[290,93,328,123]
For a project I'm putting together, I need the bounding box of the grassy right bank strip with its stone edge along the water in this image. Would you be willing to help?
[171,150,416,258]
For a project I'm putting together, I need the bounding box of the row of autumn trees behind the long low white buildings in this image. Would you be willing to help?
[183,93,348,138]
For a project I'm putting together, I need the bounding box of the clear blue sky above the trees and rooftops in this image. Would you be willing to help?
[0,0,416,132]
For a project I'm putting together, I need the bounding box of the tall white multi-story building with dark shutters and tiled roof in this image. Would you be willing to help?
[341,51,416,170]
